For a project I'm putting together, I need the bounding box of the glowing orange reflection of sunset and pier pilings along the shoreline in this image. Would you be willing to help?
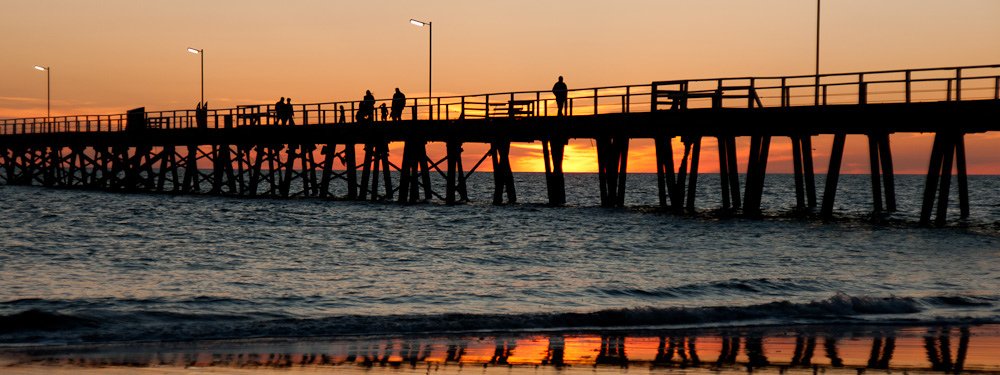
[0,326,1000,373]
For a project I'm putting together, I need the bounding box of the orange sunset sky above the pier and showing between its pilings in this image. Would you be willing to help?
[0,0,1000,174]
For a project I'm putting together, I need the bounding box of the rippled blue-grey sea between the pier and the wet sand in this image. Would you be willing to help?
[0,174,1000,345]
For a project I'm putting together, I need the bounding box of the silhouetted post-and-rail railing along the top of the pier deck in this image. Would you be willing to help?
[0,64,1000,135]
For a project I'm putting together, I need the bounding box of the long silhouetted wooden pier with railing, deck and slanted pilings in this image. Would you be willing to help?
[0,65,1000,225]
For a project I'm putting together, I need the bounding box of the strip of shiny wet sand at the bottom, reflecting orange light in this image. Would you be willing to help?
[0,324,1000,374]
